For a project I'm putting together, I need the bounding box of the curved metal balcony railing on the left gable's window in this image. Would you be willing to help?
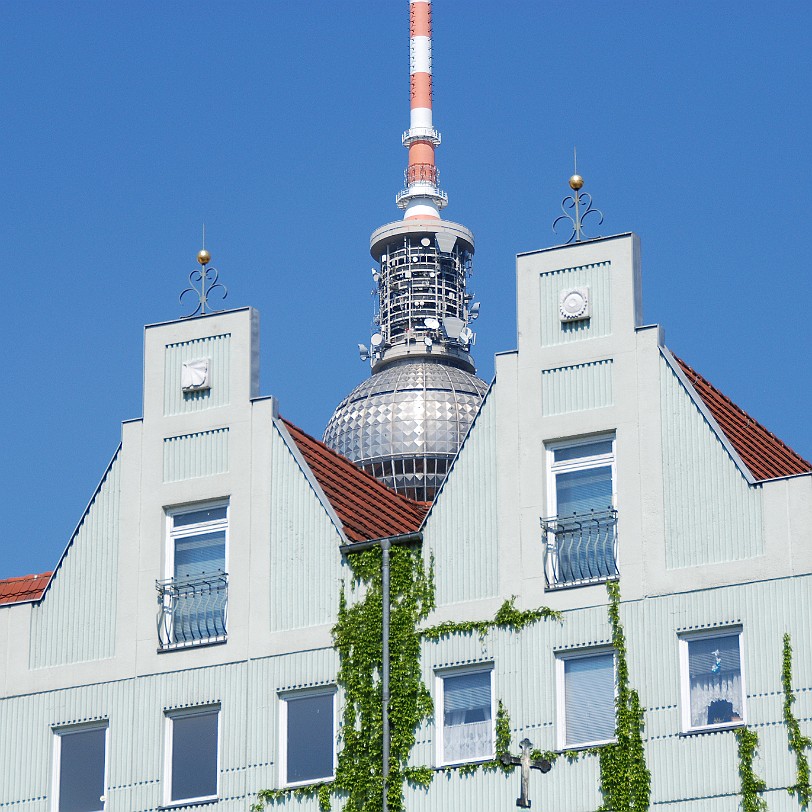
[155,571,228,651]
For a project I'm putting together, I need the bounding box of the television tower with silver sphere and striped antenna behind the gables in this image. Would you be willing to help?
[324,0,487,501]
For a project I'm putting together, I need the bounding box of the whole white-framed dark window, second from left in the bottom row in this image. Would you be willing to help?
[164,706,220,805]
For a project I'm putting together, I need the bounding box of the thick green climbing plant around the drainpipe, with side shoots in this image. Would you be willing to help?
[252,546,561,812]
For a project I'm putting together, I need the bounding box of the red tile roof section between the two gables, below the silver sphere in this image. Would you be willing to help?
[282,418,430,541]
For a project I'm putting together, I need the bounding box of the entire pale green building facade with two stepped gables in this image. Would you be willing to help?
[0,235,812,812]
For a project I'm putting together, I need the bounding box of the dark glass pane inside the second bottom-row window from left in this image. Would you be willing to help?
[172,711,218,801]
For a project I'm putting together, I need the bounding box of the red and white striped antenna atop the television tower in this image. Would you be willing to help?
[396,0,448,220]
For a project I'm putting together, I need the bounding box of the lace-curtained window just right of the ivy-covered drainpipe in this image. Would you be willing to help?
[437,668,494,764]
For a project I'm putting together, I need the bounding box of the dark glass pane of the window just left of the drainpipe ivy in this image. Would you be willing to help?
[287,694,334,784]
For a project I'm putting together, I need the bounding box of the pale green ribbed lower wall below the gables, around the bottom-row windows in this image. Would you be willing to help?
[11,576,812,812]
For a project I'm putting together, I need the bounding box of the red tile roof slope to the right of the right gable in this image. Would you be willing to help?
[674,355,812,479]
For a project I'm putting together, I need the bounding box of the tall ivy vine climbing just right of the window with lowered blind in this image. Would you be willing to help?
[595,581,651,812]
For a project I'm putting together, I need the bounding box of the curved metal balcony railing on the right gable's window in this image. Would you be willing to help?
[541,510,618,589]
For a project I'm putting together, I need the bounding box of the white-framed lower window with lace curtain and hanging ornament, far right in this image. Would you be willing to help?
[679,631,745,731]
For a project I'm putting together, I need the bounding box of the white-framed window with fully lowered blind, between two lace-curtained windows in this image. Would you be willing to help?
[556,651,615,750]
